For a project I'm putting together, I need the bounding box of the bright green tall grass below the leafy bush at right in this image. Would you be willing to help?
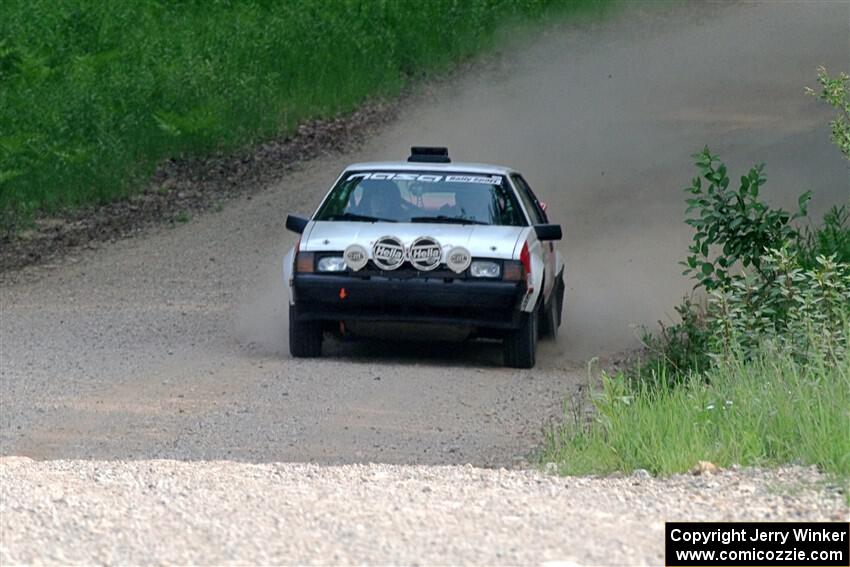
[541,338,850,479]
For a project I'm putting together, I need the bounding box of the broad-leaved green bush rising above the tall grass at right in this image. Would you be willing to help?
[668,148,850,368]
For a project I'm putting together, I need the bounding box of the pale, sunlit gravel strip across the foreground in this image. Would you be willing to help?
[0,457,850,565]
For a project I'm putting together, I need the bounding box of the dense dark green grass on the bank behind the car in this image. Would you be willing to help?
[0,0,608,230]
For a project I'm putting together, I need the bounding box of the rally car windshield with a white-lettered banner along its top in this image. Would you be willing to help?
[315,171,527,226]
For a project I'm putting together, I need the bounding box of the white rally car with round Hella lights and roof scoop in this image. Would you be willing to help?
[283,147,564,368]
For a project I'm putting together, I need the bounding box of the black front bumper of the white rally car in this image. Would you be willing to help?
[293,274,525,329]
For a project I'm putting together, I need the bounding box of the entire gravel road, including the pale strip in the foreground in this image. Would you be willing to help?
[0,1,850,563]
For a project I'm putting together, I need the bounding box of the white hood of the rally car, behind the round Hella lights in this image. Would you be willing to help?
[300,221,528,260]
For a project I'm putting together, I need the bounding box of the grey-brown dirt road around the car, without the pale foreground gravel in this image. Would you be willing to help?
[0,1,850,564]
